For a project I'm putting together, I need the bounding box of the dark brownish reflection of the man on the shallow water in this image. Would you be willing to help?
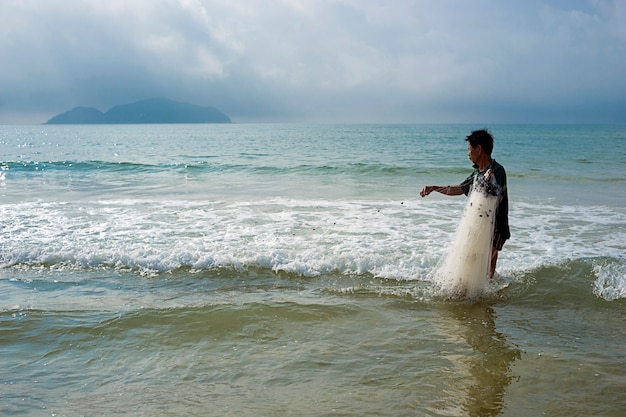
[434,303,521,417]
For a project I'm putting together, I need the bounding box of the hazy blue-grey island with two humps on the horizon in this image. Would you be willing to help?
[45,98,231,125]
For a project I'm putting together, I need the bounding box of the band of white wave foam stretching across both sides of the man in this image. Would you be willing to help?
[0,197,626,296]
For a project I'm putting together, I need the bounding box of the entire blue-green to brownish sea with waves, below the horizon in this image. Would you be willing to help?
[0,124,626,417]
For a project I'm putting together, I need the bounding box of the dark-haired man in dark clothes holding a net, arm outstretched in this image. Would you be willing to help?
[420,129,511,278]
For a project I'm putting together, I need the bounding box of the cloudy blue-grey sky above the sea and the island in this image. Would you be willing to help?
[0,0,626,124]
